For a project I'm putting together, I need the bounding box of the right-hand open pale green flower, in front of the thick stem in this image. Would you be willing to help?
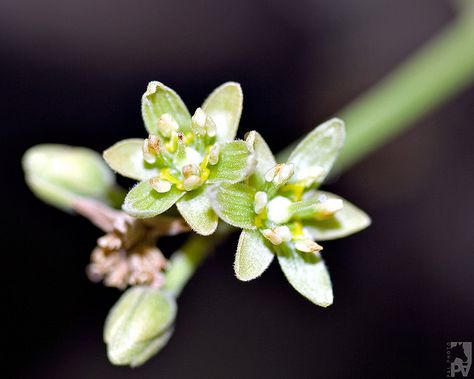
[210,119,370,307]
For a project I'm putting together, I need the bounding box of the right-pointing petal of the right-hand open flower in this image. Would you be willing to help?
[304,191,370,241]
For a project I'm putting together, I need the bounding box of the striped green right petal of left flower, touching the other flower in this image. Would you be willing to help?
[207,141,255,183]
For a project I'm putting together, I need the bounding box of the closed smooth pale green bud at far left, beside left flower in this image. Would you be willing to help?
[22,144,115,210]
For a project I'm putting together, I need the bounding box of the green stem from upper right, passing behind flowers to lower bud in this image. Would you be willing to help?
[166,10,474,295]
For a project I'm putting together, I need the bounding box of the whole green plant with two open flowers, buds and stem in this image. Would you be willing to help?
[23,8,474,366]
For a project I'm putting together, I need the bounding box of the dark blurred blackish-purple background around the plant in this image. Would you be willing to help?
[0,0,474,379]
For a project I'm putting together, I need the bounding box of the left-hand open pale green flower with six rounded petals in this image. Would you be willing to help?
[104,82,255,235]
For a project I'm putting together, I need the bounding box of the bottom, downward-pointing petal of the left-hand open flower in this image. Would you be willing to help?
[176,186,218,236]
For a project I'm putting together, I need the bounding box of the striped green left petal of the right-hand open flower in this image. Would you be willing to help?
[208,183,255,229]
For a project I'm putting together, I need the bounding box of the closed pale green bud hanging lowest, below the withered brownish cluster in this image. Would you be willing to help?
[104,286,177,367]
